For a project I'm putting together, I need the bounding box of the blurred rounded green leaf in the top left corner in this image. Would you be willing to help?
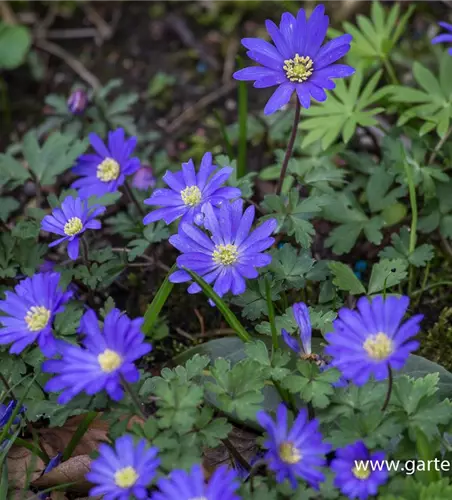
[0,21,31,70]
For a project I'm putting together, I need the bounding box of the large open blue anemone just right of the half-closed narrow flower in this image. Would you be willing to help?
[325,296,423,386]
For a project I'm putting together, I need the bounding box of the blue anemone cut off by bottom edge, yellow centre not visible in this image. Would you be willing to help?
[151,465,240,500]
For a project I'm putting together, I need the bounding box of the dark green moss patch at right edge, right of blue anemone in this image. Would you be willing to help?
[419,307,452,370]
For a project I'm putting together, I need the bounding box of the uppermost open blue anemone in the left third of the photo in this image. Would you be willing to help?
[71,128,140,198]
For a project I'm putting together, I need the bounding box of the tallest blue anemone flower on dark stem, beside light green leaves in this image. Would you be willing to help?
[233,5,355,115]
